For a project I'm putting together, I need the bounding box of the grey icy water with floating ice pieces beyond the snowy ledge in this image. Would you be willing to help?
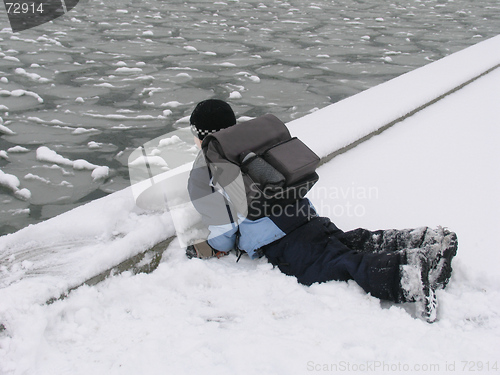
[0,0,500,235]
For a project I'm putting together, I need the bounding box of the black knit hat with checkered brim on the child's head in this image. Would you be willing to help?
[189,99,236,140]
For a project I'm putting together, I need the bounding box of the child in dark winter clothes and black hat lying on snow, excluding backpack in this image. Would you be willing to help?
[186,99,457,322]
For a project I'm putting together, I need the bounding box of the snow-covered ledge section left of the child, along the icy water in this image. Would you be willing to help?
[0,189,174,306]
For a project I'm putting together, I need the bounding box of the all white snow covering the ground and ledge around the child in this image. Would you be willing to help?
[0,37,500,374]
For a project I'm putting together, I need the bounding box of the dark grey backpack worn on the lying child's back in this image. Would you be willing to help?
[202,114,320,220]
